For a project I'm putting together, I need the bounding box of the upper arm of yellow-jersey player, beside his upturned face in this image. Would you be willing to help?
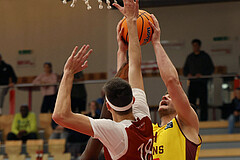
[167,82,199,130]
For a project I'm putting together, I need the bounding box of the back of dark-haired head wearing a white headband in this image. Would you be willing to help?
[103,78,134,115]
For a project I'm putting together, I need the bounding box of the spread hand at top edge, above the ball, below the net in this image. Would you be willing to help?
[113,0,139,20]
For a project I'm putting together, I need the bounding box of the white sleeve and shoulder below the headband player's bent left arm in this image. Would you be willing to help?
[89,117,128,159]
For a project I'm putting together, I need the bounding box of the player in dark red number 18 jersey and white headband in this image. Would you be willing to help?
[53,0,153,160]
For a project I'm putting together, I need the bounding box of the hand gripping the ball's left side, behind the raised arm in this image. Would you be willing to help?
[117,20,128,53]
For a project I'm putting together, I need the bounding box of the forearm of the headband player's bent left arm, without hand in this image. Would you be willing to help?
[53,73,74,124]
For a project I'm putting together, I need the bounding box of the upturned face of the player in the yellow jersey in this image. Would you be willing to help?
[158,93,177,118]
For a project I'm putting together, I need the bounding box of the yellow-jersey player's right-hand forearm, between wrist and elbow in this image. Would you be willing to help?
[153,42,179,85]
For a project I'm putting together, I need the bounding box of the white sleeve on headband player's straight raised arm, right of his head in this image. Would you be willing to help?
[132,88,151,119]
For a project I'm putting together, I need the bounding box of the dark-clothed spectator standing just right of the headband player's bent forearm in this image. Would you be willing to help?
[71,72,87,113]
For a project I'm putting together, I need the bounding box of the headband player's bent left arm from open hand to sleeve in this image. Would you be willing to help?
[52,45,93,136]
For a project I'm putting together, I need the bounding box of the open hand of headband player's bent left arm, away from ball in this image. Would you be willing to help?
[64,45,93,75]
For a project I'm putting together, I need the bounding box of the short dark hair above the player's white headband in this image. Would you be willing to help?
[103,78,133,107]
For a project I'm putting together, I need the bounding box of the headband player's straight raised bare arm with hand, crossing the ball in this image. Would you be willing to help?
[113,0,144,90]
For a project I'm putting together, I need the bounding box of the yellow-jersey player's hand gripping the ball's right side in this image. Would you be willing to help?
[149,14,161,44]
